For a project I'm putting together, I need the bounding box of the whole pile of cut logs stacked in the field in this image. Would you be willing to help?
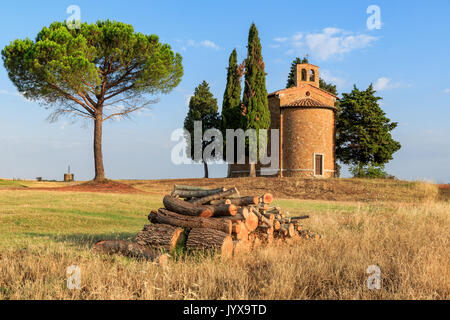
[93,185,320,264]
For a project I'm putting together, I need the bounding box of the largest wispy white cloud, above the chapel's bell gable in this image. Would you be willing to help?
[276,27,377,60]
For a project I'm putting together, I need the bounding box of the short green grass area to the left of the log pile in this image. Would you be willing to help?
[0,190,162,247]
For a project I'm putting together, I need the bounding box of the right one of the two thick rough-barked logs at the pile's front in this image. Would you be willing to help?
[186,228,233,258]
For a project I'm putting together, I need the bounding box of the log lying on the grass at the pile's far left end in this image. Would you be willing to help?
[92,240,169,265]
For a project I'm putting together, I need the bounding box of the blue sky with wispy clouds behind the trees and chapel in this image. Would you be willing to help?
[0,0,450,183]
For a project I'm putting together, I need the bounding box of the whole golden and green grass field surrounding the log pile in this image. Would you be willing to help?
[0,178,450,299]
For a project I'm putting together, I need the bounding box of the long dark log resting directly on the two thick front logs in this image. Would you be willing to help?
[148,209,232,234]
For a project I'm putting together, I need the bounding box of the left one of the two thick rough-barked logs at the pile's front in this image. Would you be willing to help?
[136,224,186,252]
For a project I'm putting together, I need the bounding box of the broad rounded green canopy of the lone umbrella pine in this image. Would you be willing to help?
[2,20,183,119]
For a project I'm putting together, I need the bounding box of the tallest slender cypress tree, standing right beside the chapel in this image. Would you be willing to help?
[241,23,270,177]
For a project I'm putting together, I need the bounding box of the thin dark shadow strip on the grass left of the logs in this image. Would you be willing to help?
[25,232,136,248]
